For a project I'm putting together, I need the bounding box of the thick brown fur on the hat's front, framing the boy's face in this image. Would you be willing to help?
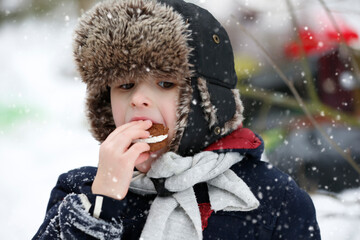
[73,0,192,142]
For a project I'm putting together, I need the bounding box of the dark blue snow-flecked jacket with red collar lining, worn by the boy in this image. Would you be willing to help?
[34,129,320,240]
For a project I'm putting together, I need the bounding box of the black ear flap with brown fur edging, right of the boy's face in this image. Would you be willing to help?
[172,77,243,156]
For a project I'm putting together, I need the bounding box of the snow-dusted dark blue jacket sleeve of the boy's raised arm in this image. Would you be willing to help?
[33,170,126,239]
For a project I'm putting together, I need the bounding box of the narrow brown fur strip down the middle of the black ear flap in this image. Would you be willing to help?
[198,78,218,128]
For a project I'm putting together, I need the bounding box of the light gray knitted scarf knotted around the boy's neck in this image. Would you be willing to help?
[130,152,259,240]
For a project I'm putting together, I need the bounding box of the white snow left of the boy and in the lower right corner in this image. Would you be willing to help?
[0,12,360,240]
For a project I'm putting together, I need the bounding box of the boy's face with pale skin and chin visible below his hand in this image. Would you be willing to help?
[110,76,179,172]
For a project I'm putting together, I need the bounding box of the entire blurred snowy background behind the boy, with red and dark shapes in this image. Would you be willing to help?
[0,0,360,240]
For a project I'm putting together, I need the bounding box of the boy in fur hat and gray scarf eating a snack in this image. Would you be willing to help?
[34,0,320,240]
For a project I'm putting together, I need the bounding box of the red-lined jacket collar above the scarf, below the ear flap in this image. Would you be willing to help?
[204,127,264,160]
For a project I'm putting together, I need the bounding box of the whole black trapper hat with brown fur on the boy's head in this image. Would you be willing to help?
[74,0,243,156]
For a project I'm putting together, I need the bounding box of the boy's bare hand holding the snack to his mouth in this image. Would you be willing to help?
[91,120,152,200]
